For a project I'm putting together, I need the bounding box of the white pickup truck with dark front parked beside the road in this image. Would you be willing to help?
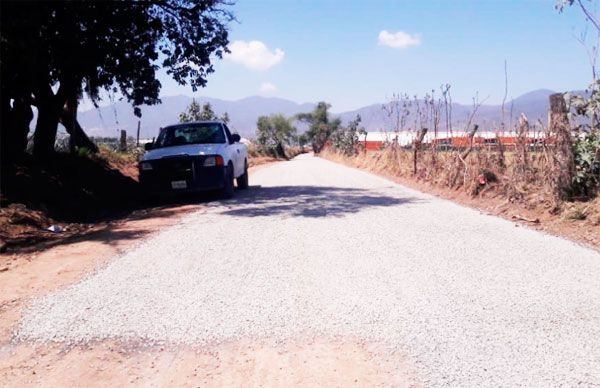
[139,121,248,198]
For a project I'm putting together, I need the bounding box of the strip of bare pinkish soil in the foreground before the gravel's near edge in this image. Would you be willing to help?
[0,338,419,387]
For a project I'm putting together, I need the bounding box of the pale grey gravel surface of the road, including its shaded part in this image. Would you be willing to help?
[16,155,600,387]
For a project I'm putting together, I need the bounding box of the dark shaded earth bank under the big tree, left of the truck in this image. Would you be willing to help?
[0,153,142,252]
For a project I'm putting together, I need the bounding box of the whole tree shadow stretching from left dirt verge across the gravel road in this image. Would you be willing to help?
[3,186,420,253]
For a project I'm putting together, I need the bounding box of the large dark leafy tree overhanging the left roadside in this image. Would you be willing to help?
[0,0,233,157]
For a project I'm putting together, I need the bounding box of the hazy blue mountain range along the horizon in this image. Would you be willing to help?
[78,89,568,138]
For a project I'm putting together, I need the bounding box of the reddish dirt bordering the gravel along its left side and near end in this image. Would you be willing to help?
[0,164,419,387]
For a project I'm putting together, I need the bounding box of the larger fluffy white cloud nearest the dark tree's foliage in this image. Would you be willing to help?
[225,40,285,70]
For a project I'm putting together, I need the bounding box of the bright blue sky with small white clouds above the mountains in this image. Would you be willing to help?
[160,0,591,112]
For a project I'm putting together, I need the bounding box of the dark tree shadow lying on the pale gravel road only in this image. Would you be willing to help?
[221,186,420,218]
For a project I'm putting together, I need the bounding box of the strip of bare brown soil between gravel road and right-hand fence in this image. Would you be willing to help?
[321,153,600,250]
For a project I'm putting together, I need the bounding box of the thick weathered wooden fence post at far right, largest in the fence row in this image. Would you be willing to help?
[548,93,575,201]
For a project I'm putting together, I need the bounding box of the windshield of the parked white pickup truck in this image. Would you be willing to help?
[155,123,225,147]
